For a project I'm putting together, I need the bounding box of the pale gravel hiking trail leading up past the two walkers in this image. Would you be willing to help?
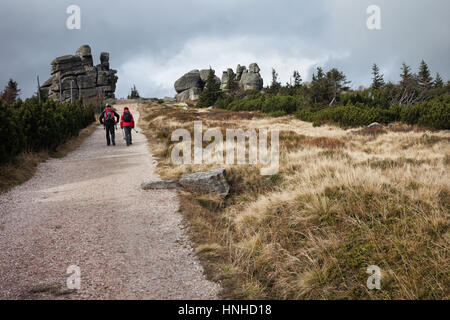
[0,105,219,299]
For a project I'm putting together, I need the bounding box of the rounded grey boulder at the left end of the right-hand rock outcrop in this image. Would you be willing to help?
[175,69,220,102]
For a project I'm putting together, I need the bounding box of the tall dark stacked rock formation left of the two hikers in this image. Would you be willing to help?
[41,45,118,102]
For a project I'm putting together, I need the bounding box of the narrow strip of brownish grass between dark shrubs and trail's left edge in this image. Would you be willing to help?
[0,123,98,193]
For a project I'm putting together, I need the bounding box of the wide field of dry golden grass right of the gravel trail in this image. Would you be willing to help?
[140,105,450,299]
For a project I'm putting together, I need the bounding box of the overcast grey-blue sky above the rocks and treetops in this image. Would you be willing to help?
[0,0,450,98]
